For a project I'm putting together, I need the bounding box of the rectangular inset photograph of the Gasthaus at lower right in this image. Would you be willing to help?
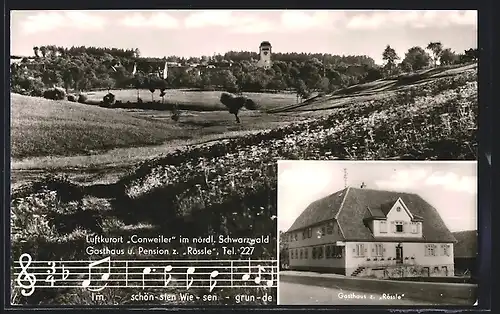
[278,161,477,305]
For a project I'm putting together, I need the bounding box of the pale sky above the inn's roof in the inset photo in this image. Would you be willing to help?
[278,161,477,232]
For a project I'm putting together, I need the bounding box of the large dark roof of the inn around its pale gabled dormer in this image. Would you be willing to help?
[288,187,456,242]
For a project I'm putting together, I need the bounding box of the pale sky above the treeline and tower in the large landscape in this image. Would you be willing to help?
[11,10,477,64]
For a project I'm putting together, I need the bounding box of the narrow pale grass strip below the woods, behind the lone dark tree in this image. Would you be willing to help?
[86,89,297,111]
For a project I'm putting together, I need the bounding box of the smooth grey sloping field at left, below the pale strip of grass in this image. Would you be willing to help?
[11,94,295,160]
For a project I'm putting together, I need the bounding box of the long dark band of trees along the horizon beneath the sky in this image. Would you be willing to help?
[11,43,477,96]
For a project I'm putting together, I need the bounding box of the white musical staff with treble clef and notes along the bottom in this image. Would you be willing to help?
[13,254,278,296]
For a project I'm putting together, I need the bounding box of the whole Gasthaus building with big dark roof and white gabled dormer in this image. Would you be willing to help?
[287,187,456,278]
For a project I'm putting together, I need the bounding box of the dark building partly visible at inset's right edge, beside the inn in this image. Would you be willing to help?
[453,230,477,275]
